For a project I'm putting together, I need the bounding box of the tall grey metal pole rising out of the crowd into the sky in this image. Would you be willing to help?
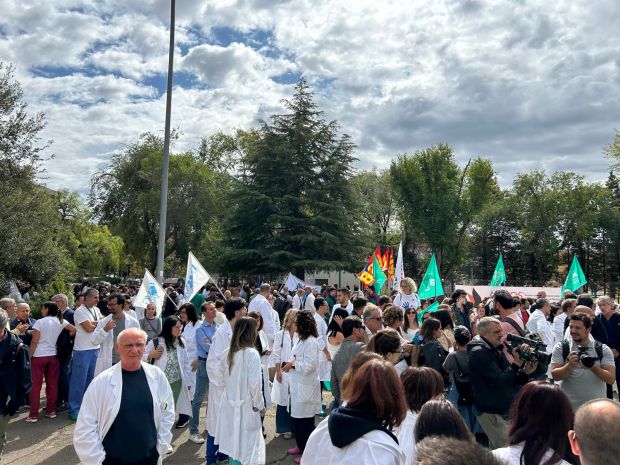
[155,0,175,284]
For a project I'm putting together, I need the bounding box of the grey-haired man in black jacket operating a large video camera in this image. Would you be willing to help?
[467,317,538,449]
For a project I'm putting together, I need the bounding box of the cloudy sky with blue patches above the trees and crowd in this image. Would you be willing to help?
[0,0,620,193]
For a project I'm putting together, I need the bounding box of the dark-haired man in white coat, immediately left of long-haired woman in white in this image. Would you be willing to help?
[206,296,248,465]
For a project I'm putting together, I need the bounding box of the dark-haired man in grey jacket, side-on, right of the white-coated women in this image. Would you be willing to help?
[330,316,365,410]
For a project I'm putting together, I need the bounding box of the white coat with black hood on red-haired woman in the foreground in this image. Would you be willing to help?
[301,417,406,465]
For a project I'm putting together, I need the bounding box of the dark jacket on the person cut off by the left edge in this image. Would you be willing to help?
[0,331,32,415]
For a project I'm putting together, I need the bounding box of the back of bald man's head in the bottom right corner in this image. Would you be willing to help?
[568,399,620,465]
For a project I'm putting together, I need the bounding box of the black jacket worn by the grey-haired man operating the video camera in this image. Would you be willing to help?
[467,336,529,415]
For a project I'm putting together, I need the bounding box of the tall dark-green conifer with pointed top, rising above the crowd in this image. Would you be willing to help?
[224,79,360,278]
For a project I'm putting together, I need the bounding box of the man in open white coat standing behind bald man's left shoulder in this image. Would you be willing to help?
[90,293,140,376]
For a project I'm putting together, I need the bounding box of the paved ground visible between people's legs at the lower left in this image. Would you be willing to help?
[0,399,331,465]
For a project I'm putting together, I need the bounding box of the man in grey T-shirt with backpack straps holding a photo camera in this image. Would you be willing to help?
[551,312,616,410]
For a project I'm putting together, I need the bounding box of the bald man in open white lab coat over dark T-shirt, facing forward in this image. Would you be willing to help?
[73,328,175,465]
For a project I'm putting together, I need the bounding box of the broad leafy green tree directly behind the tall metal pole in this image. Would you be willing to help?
[90,134,227,273]
